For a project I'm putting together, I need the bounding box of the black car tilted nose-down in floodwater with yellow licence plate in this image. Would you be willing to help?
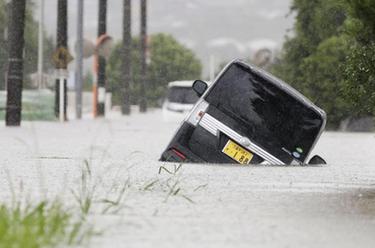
[160,60,326,165]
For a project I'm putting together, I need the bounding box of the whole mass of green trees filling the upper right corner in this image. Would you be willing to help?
[271,0,375,129]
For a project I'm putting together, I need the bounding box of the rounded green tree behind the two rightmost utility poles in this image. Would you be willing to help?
[107,34,202,106]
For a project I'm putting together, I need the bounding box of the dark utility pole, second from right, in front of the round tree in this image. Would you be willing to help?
[121,0,132,115]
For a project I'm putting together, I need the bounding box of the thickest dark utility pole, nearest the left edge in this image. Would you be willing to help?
[5,0,26,126]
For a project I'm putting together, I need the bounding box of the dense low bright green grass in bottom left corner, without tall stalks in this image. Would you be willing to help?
[0,201,93,248]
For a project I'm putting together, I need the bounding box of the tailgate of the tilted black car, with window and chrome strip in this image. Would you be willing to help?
[189,63,322,164]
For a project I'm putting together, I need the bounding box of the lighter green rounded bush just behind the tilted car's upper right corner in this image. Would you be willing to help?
[300,35,351,126]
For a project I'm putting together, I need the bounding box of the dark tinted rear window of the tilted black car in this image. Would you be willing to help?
[206,64,323,162]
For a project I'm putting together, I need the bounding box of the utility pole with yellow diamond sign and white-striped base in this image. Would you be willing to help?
[54,0,70,122]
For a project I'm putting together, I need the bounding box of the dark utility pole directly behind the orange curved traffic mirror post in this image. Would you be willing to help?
[96,0,107,116]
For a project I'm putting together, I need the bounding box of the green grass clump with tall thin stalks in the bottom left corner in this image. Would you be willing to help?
[0,160,99,248]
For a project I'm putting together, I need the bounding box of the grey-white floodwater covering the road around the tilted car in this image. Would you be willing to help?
[0,110,375,248]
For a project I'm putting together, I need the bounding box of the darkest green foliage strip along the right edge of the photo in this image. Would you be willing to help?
[344,0,375,116]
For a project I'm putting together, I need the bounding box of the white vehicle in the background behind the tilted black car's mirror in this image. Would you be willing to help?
[163,81,199,122]
